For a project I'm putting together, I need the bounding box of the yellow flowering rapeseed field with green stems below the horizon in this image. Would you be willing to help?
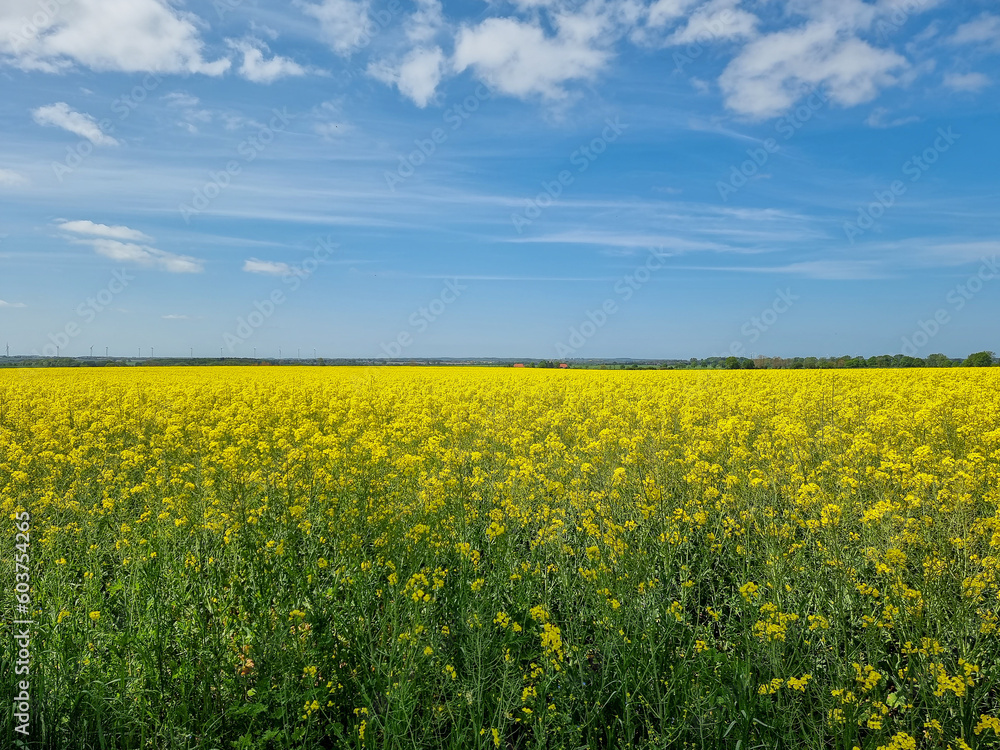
[0,368,1000,750]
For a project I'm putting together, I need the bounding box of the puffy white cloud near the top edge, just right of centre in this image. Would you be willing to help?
[453,14,610,99]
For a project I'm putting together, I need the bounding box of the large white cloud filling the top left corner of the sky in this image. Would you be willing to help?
[0,0,230,75]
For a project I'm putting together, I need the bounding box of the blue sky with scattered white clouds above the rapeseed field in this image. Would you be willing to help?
[0,0,1000,358]
